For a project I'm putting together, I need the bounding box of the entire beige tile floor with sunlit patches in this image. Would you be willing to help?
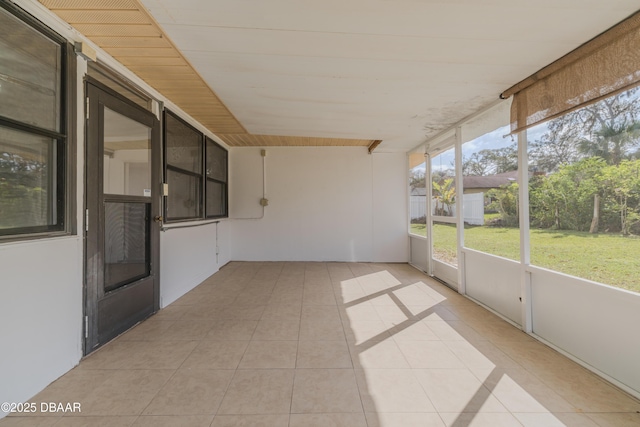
[0,262,640,427]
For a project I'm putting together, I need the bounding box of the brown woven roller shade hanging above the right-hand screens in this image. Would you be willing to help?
[500,12,640,133]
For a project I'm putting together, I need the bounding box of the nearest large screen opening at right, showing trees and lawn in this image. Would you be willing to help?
[527,87,640,292]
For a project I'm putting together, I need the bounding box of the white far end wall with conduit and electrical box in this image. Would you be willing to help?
[230,147,409,262]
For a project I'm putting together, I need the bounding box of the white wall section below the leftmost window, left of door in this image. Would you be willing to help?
[0,236,83,412]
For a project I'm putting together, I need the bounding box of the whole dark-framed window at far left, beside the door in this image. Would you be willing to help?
[0,3,75,238]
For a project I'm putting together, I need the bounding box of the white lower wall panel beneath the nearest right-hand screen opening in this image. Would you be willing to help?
[528,267,640,396]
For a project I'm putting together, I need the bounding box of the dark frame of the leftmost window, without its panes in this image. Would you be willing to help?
[0,2,77,242]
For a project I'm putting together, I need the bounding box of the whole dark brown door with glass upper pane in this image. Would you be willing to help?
[85,81,160,354]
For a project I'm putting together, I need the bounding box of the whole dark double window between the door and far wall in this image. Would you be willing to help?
[164,111,228,221]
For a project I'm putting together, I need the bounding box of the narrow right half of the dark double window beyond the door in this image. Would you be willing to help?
[206,138,228,218]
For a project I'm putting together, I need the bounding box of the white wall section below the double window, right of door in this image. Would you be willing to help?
[160,223,222,308]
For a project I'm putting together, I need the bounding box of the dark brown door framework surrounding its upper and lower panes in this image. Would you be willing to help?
[83,76,162,355]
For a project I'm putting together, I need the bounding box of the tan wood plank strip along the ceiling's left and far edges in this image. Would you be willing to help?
[39,0,374,147]
